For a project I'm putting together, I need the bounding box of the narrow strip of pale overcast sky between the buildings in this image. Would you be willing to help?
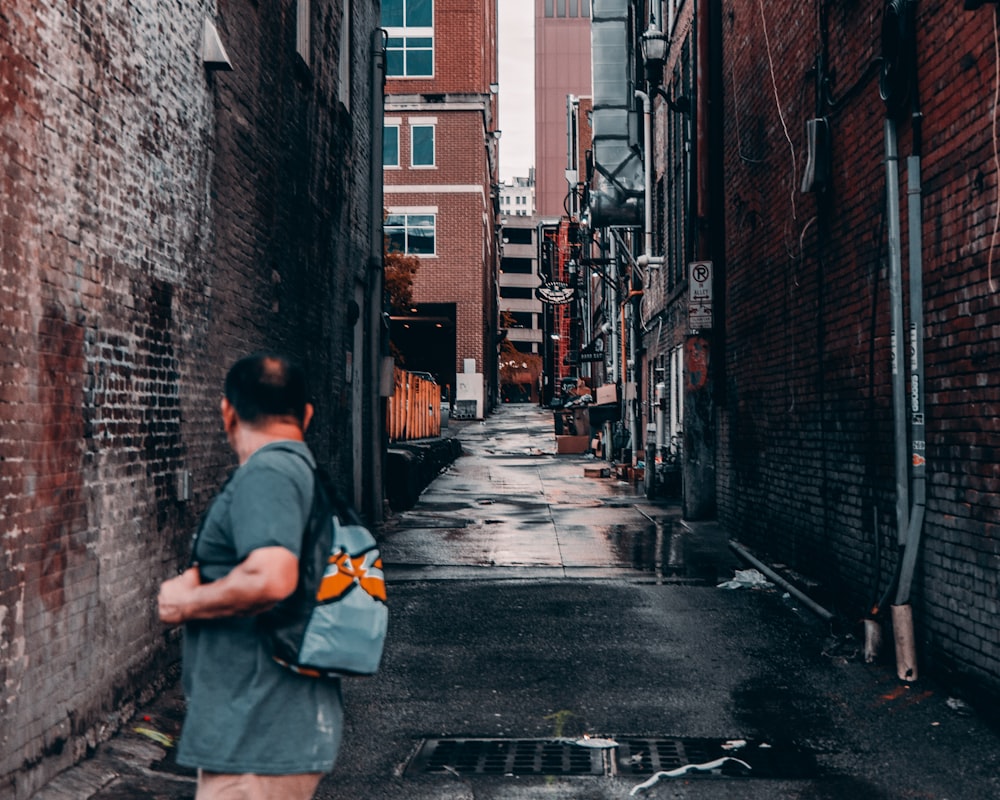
[497,0,535,181]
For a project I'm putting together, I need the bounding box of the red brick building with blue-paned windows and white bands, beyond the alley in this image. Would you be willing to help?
[382,0,500,416]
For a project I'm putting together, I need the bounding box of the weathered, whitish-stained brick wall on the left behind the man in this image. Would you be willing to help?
[0,0,378,798]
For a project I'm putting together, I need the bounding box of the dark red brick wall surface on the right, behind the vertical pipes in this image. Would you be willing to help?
[718,0,1000,691]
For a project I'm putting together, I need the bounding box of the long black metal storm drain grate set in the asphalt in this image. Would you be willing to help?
[406,736,816,779]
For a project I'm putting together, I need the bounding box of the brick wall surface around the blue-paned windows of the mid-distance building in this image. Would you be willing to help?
[385,0,499,410]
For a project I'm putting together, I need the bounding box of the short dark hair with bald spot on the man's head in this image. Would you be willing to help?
[225,351,309,425]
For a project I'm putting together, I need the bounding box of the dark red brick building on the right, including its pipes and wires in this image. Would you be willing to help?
[633,0,1000,699]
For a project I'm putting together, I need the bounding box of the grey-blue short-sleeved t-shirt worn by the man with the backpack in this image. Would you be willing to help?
[177,441,344,775]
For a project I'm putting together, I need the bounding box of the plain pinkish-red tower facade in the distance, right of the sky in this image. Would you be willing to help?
[535,0,591,217]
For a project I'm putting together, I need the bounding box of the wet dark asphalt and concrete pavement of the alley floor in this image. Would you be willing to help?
[36,405,1000,800]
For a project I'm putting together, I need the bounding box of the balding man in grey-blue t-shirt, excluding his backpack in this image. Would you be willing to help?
[159,353,343,800]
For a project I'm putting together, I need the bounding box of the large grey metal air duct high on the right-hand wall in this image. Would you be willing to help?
[588,0,644,228]
